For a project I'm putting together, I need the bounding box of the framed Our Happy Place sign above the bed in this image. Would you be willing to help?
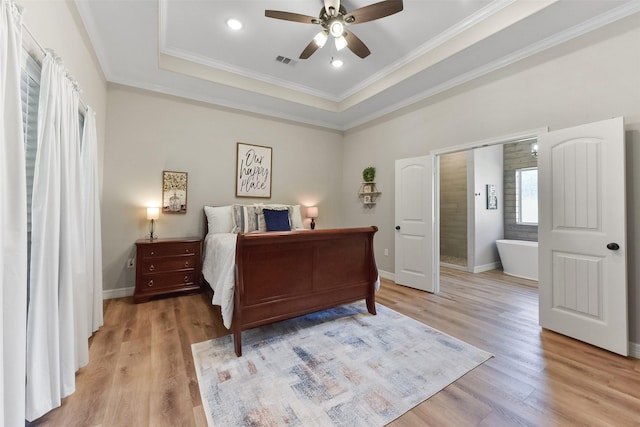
[236,142,271,199]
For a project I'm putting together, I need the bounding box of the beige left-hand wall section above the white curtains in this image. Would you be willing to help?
[19,0,107,189]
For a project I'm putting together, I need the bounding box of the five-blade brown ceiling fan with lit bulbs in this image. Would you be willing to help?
[264,0,403,59]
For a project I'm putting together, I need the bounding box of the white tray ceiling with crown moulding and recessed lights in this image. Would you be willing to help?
[76,0,640,130]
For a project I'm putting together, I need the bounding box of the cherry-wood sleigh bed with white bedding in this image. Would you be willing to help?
[203,205,379,356]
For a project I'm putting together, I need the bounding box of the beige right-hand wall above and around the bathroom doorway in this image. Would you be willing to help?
[343,14,640,342]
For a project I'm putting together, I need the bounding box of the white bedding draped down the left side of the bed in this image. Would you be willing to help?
[202,233,380,329]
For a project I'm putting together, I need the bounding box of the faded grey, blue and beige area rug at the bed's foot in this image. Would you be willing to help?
[191,302,491,427]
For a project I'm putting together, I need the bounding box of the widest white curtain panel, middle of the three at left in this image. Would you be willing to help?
[26,52,89,421]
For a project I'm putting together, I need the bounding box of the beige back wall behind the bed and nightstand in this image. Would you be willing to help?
[102,85,344,290]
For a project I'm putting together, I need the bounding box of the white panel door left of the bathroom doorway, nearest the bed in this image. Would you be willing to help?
[395,156,438,292]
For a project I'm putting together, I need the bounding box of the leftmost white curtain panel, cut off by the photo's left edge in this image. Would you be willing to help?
[0,0,27,426]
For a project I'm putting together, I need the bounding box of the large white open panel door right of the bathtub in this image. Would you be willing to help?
[538,117,629,356]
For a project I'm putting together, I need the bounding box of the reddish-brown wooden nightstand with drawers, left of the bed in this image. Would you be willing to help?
[133,237,202,303]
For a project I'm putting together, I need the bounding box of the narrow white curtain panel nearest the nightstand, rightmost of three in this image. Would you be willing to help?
[82,107,103,338]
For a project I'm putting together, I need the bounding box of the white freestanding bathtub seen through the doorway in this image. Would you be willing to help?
[496,240,538,280]
